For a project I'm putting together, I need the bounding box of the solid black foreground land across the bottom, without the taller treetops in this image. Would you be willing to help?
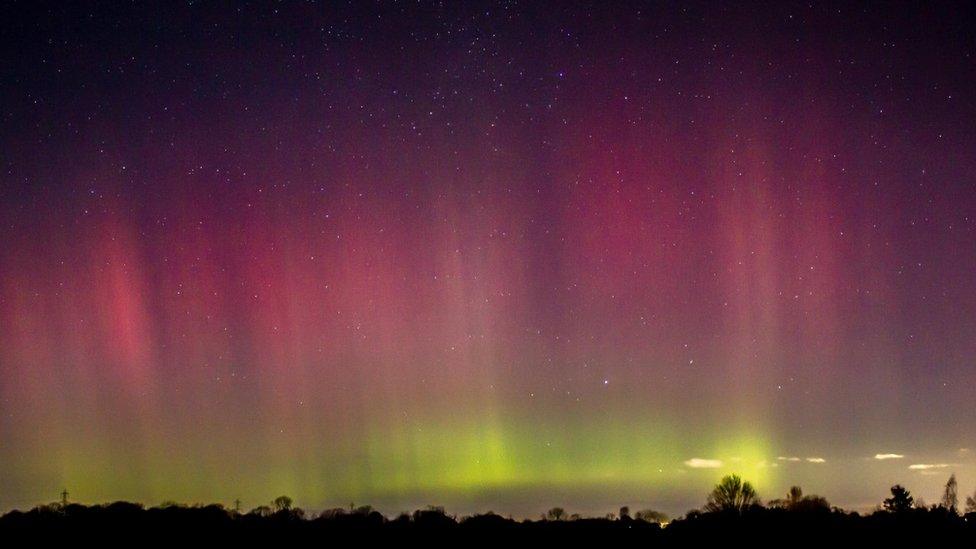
[0,502,976,547]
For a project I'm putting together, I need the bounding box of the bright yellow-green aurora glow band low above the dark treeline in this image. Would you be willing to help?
[28,404,773,507]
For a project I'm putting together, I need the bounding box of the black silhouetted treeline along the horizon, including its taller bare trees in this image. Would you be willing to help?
[0,475,976,547]
